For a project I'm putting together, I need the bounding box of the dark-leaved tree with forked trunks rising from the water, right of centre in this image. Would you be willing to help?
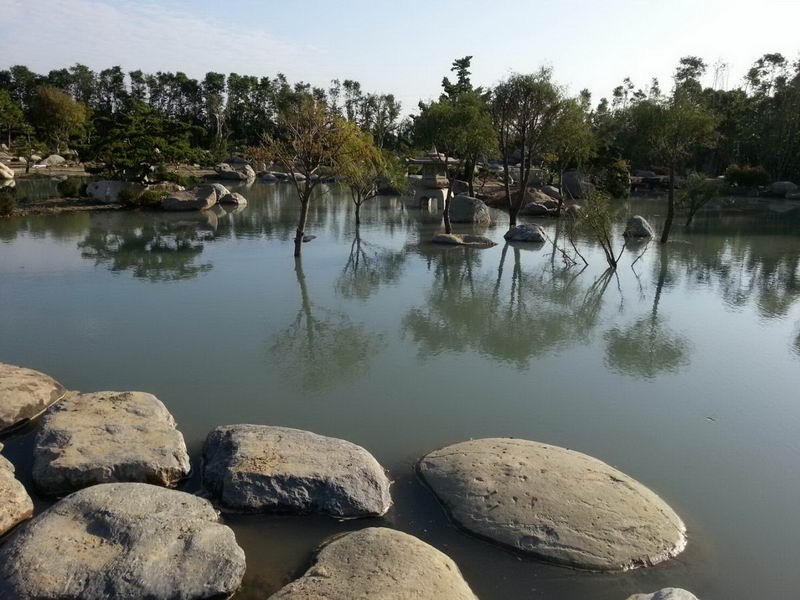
[492,69,561,227]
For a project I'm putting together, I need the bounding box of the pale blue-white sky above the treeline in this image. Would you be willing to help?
[0,0,800,112]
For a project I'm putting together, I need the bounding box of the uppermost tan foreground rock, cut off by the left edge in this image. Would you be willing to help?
[0,363,65,431]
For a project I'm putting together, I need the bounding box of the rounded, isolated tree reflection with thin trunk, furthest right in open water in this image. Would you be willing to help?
[604,247,691,379]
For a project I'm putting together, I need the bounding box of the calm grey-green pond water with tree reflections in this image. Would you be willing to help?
[0,184,800,600]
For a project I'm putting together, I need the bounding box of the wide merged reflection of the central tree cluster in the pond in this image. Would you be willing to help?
[402,244,612,368]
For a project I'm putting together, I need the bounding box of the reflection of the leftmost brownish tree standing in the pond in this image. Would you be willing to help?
[270,258,383,391]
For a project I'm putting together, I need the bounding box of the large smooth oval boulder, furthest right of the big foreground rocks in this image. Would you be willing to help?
[419,438,686,571]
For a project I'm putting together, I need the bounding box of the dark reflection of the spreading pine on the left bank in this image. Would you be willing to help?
[78,211,218,281]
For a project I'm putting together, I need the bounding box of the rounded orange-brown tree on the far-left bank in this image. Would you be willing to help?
[30,85,87,152]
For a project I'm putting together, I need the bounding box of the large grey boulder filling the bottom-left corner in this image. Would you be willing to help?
[0,483,245,600]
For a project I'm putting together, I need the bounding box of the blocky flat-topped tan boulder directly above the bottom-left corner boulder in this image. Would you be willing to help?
[33,392,191,495]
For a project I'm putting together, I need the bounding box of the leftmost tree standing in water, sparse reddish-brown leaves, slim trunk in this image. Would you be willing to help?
[250,94,352,257]
